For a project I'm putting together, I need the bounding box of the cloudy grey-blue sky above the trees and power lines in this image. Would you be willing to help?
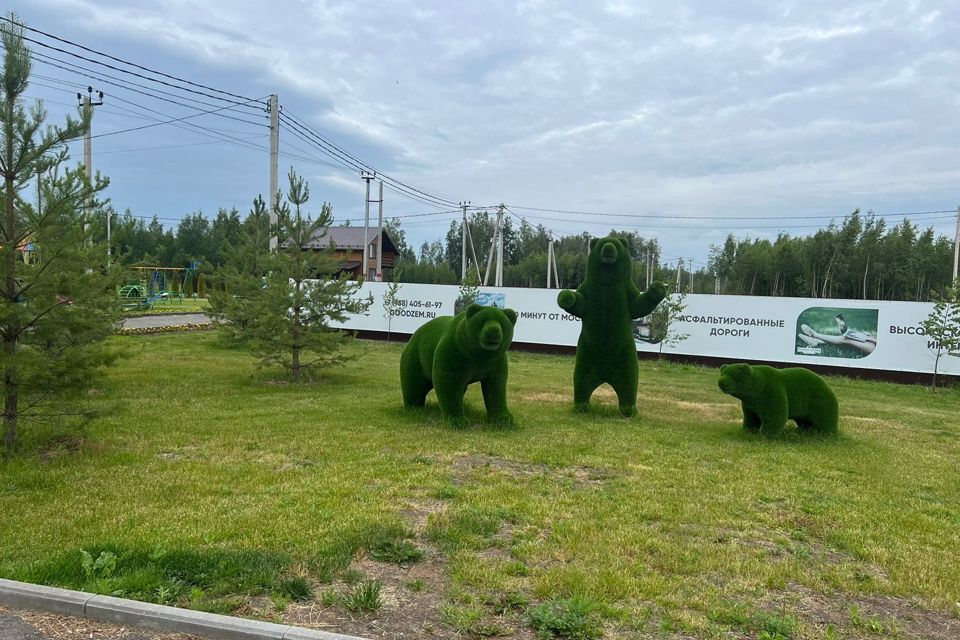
[15,0,960,270]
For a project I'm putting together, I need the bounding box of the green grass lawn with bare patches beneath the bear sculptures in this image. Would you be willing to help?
[0,334,960,640]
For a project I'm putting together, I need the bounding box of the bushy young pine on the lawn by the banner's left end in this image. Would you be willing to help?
[214,169,372,382]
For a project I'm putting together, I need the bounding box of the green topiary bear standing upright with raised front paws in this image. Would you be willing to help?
[557,236,667,416]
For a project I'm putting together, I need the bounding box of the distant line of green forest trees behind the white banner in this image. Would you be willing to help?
[88,204,953,301]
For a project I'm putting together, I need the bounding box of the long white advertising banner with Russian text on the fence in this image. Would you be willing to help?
[332,282,960,375]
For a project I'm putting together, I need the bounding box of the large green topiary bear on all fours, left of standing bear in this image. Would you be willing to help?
[400,304,517,427]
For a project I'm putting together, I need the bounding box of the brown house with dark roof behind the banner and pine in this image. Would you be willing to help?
[303,227,397,281]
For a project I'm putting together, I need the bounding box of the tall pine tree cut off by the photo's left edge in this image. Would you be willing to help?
[0,13,120,452]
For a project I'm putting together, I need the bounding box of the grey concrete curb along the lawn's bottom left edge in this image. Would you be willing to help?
[0,578,363,640]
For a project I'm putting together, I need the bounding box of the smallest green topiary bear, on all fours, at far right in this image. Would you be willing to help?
[718,363,840,435]
